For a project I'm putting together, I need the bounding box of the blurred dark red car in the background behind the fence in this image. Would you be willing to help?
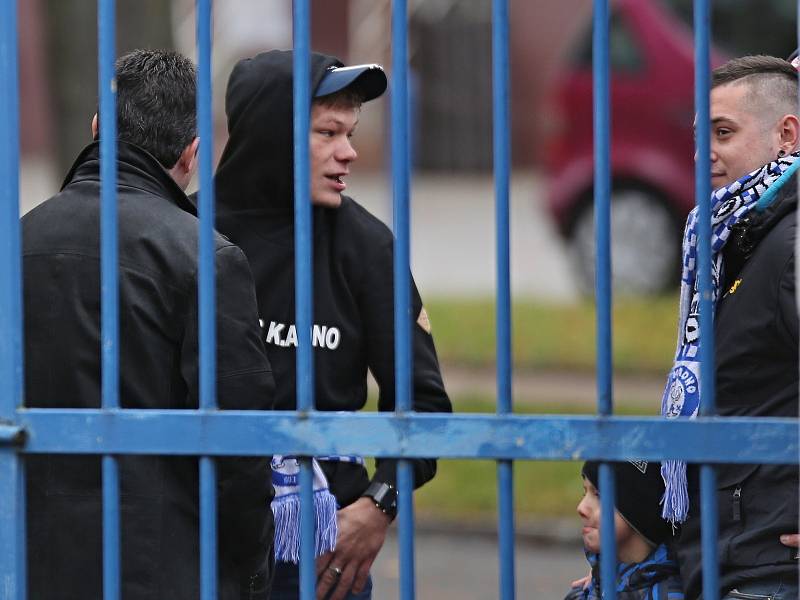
[545,0,795,294]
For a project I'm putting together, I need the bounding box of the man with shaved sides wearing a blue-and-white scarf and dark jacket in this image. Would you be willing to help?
[662,56,800,600]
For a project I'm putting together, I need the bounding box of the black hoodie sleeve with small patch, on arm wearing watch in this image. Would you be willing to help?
[361,237,452,488]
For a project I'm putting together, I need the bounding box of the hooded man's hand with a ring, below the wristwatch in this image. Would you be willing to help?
[317,498,391,600]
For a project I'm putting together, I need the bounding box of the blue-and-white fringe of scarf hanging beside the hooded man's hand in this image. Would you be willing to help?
[272,489,339,564]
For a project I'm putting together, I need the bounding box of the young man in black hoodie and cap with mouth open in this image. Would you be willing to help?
[211,51,451,600]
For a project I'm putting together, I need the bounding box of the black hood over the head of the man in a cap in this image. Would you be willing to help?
[215,50,342,216]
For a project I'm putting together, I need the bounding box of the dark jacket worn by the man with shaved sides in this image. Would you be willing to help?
[677,179,798,599]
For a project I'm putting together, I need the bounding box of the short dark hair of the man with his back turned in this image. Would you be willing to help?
[108,50,197,169]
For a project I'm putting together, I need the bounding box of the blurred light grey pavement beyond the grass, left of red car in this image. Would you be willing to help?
[348,171,577,301]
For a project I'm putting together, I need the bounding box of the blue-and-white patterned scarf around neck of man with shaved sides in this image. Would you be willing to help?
[661,154,800,524]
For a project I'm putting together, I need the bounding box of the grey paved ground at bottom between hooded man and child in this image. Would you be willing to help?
[372,530,587,600]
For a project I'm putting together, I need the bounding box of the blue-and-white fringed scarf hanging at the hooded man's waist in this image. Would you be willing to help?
[272,454,364,564]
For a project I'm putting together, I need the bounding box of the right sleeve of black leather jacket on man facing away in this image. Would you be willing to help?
[181,246,275,597]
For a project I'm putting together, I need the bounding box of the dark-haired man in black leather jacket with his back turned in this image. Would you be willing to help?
[22,50,274,600]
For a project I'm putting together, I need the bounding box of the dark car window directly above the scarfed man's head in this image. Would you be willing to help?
[663,0,797,58]
